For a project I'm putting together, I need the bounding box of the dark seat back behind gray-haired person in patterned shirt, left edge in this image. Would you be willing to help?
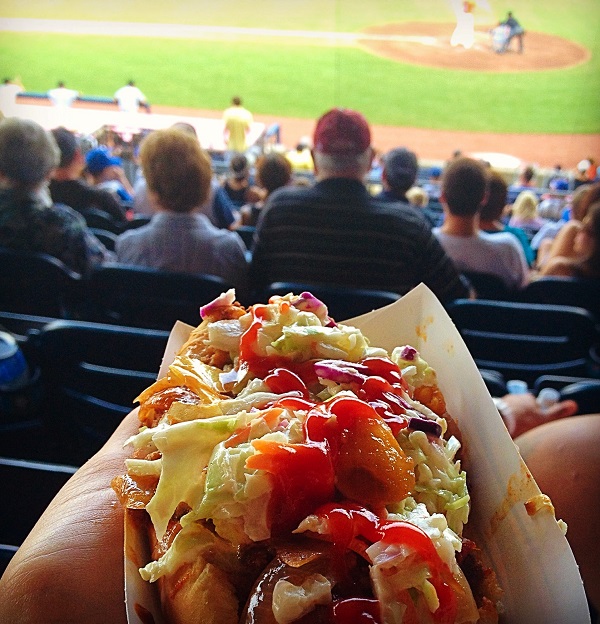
[0,248,81,318]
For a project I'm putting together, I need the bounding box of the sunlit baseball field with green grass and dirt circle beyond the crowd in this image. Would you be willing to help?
[0,0,600,163]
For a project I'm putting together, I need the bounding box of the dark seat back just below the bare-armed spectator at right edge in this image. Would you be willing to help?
[519,276,600,323]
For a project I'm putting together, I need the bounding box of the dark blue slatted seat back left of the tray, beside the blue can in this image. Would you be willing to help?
[30,321,169,465]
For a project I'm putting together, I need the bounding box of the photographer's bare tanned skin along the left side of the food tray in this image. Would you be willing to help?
[0,409,139,624]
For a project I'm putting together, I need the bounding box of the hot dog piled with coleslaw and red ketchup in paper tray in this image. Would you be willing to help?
[113,291,501,624]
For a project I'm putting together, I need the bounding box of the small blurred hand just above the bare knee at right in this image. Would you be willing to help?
[499,392,578,438]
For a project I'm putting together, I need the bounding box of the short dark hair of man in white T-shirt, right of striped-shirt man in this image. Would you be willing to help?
[442,156,488,217]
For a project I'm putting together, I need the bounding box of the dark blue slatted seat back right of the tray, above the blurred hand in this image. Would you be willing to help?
[448,299,598,386]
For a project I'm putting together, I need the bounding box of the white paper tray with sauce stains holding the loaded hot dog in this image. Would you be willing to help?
[125,285,590,624]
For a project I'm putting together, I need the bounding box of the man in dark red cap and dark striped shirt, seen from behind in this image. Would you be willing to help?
[251,108,468,301]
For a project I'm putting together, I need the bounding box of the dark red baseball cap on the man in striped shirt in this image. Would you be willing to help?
[313,108,371,156]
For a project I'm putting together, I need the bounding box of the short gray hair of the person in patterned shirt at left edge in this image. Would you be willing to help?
[0,117,60,190]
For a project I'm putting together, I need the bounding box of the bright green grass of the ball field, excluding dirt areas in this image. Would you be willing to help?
[0,0,600,133]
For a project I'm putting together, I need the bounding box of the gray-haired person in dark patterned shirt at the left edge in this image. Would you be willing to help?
[0,117,112,275]
